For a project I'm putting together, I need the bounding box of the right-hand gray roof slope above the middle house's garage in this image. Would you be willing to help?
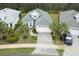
[35,9,52,26]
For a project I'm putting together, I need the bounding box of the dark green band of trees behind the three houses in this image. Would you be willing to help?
[0,3,79,12]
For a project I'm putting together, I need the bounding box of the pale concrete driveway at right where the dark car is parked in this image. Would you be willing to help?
[64,35,79,56]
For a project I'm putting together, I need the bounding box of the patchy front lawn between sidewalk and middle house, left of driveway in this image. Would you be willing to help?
[16,29,37,44]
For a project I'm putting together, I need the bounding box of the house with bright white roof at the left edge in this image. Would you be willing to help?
[0,8,21,28]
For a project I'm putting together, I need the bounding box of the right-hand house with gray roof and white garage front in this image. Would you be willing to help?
[59,10,79,37]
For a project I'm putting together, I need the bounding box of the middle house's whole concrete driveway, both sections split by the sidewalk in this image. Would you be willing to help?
[32,33,58,55]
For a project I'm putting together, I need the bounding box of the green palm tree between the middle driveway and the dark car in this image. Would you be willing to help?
[51,22,68,42]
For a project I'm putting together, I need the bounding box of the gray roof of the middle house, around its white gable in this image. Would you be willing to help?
[24,9,52,25]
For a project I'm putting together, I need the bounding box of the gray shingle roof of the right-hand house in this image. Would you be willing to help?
[59,10,79,28]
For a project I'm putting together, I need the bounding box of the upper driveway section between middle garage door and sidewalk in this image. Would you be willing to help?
[37,33,53,44]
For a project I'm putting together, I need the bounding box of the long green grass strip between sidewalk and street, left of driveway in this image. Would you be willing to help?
[0,48,34,56]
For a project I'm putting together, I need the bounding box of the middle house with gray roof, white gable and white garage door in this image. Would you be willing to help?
[23,9,52,32]
